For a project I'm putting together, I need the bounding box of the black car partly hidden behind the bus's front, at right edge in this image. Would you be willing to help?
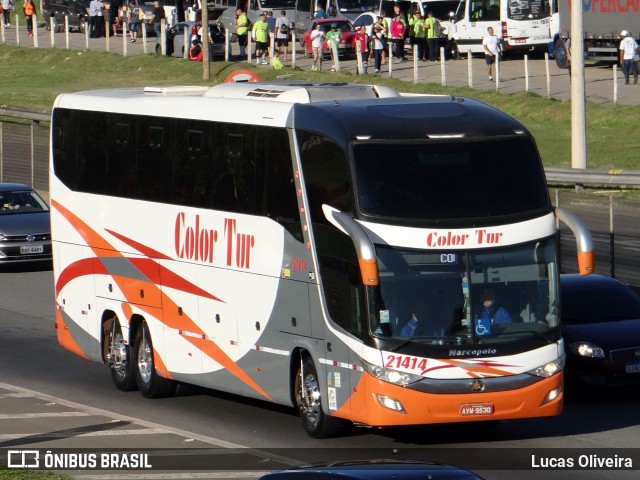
[560,274,640,387]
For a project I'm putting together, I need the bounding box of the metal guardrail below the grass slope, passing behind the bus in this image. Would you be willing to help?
[0,105,640,188]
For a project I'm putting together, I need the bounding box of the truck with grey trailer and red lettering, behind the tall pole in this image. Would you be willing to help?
[549,0,640,68]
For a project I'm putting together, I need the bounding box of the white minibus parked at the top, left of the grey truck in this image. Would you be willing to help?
[449,0,551,55]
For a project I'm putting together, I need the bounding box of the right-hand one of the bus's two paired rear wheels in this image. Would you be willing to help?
[134,323,176,398]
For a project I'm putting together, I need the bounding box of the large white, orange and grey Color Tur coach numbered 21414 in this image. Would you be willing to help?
[50,83,593,437]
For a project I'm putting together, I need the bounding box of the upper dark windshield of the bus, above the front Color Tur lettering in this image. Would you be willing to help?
[353,137,550,223]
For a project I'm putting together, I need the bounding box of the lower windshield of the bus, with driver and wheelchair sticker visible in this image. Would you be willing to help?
[371,239,559,345]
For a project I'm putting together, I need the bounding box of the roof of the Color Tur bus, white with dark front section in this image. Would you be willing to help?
[54,82,528,141]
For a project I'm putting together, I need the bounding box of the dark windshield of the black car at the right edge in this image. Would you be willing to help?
[561,282,640,325]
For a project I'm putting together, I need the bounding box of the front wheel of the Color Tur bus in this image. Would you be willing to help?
[295,356,345,438]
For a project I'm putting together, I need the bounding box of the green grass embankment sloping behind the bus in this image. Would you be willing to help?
[0,45,640,170]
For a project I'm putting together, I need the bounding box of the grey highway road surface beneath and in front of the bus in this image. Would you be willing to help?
[0,268,640,480]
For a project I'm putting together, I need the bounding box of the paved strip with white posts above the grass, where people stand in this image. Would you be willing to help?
[0,26,640,105]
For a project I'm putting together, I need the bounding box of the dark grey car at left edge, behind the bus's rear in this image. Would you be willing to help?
[0,183,51,265]
